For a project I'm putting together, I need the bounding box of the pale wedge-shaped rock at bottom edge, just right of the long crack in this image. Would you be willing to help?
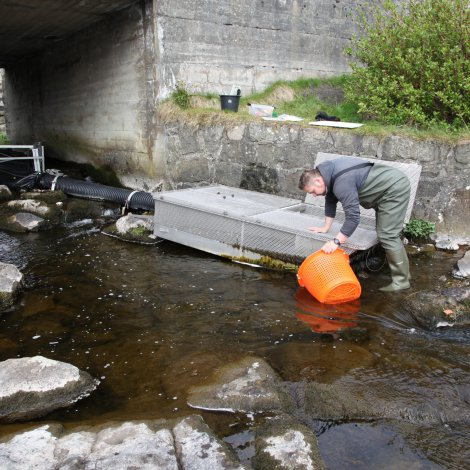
[173,416,246,470]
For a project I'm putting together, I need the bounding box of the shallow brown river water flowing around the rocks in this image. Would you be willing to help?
[0,221,470,469]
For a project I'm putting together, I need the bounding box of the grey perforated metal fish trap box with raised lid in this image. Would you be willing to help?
[153,154,420,265]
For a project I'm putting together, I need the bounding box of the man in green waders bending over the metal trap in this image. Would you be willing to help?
[299,157,410,291]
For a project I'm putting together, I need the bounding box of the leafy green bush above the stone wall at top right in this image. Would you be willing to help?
[346,0,470,128]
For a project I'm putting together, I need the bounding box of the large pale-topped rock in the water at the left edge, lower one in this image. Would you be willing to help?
[0,356,99,423]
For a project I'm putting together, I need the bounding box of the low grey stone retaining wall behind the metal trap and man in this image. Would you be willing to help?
[161,122,470,243]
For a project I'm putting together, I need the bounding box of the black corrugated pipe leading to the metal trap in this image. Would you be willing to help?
[36,173,155,211]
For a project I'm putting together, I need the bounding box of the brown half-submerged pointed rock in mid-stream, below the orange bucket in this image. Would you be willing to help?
[188,357,290,413]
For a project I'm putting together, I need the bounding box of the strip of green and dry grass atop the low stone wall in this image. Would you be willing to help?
[159,75,470,143]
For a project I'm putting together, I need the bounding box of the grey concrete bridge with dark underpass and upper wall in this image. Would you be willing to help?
[0,0,357,184]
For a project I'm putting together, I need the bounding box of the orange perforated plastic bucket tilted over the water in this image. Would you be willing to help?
[297,248,361,304]
